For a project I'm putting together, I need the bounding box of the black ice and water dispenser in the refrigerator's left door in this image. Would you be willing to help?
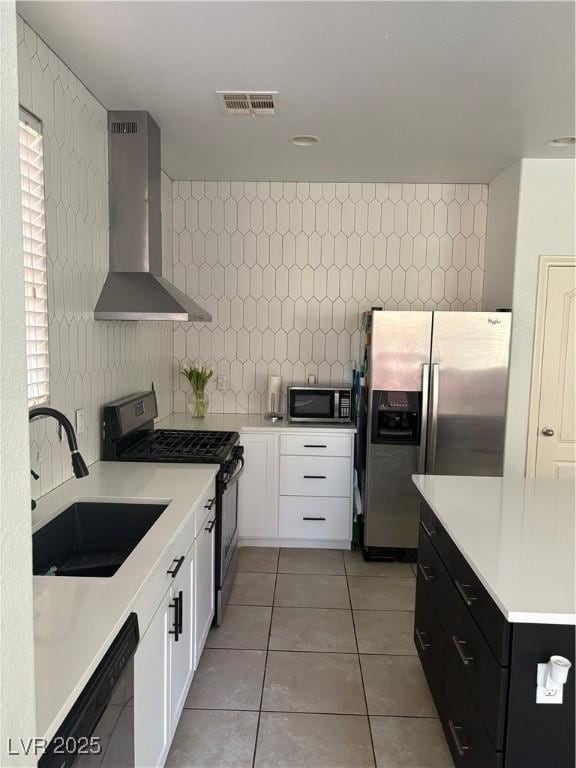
[372,391,422,445]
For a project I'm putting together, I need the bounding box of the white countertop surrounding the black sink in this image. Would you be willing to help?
[33,462,218,740]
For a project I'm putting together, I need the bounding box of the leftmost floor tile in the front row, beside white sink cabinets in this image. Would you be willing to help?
[166,709,258,768]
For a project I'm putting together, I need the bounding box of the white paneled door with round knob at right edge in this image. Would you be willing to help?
[536,266,576,478]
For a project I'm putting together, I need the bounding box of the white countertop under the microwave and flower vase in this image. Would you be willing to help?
[156,413,356,434]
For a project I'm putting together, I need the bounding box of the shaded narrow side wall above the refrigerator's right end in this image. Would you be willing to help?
[482,162,522,311]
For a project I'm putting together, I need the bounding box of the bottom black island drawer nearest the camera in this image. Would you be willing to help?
[442,654,502,768]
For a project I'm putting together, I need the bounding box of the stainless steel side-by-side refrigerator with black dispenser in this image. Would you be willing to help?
[356,310,511,556]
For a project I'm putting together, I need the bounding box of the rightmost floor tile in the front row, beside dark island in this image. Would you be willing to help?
[370,717,454,768]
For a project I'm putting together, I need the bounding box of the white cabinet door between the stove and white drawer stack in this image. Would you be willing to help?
[238,433,278,538]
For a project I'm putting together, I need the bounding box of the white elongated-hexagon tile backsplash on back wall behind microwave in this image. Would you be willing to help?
[172,181,488,413]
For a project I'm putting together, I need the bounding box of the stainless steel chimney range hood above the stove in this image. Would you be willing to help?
[94,111,212,322]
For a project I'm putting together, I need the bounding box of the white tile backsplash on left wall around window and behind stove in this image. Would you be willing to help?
[18,18,173,497]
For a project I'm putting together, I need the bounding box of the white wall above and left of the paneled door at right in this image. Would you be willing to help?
[486,160,576,476]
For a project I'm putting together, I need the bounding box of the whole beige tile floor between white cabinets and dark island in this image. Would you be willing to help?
[167,547,453,768]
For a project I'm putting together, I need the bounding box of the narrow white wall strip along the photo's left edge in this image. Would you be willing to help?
[0,1,36,768]
